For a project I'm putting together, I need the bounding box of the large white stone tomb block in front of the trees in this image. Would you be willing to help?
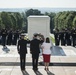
[28,16,50,39]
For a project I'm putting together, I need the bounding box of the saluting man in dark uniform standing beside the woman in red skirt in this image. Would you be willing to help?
[30,34,43,71]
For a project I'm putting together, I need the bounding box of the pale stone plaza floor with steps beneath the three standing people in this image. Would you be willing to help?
[0,45,76,75]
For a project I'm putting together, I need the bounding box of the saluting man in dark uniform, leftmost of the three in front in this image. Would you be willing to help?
[17,35,30,70]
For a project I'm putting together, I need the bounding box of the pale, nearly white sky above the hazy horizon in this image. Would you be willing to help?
[0,0,76,8]
